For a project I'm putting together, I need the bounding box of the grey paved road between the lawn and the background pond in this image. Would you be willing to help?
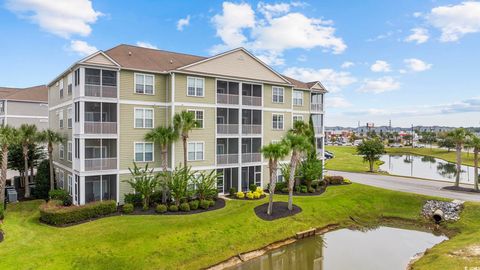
[328,171,480,202]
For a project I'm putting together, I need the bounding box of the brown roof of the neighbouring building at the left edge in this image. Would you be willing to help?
[0,85,48,103]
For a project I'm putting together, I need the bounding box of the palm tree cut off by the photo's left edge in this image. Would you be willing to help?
[0,125,17,207]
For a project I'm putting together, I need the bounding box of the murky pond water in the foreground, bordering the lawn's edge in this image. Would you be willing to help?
[231,227,447,270]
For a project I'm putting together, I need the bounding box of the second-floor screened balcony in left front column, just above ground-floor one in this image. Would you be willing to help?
[85,139,117,171]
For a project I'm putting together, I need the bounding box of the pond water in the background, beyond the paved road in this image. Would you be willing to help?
[380,155,474,184]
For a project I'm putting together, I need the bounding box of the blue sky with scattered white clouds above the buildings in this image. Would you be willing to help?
[0,0,480,126]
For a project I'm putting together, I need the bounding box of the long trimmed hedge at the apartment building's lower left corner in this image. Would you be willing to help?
[40,200,117,226]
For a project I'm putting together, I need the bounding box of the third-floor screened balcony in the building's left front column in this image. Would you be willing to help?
[85,102,117,134]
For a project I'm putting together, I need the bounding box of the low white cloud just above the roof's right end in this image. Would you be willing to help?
[284,67,357,92]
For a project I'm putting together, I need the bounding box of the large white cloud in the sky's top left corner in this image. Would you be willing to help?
[6,0,102,38]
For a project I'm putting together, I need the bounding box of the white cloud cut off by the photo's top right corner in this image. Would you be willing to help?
[426,1,480,42]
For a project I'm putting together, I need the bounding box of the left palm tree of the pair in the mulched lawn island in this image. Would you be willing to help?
[261,143,288,215]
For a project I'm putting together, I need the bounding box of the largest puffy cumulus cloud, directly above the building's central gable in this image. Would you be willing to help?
[211,2,347,65]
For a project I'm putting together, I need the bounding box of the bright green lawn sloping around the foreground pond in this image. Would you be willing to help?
[0,184,480,269]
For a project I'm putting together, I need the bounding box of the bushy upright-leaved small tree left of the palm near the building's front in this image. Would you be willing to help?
[125,162,158,210]
